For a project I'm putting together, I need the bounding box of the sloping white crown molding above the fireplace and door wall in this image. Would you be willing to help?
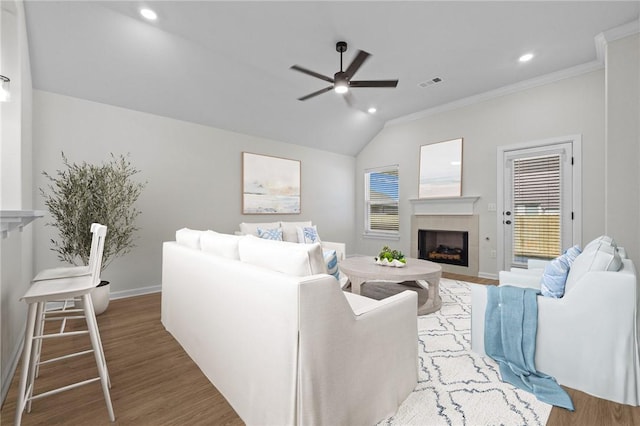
[384,61,604,127]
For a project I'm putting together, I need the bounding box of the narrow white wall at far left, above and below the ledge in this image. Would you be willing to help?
[0,1,33,400]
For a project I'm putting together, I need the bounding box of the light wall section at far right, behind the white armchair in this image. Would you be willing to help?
[606,34,640,268]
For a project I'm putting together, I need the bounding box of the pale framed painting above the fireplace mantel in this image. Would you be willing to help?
[418,138,462,198]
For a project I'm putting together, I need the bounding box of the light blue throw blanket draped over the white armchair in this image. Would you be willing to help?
[484,286,574,411]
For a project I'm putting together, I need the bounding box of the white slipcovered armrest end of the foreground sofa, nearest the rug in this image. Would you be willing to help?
[298,281,418,424]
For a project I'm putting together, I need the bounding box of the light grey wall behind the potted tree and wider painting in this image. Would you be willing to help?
[33,91,355,295]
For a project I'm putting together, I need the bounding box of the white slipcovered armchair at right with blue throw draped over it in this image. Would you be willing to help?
[471,237,640,406]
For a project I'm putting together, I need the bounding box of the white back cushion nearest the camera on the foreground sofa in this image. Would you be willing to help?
[238,235,327,277]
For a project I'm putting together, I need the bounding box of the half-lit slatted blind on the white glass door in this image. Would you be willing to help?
[513,154,562,260]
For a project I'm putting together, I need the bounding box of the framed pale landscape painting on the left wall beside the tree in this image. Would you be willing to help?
[242,152,300,214]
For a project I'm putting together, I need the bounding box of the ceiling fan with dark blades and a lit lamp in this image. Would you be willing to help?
[291,41,398,105]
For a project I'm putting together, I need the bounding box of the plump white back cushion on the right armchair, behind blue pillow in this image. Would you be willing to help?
[565,241,622,293]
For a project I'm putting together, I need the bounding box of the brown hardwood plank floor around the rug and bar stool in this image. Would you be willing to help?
[0,274,640,426]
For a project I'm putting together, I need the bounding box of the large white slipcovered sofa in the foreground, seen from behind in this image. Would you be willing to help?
[161,230,418,425]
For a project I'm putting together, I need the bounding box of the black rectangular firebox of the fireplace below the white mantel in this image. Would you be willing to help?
[418,229,469,266]
